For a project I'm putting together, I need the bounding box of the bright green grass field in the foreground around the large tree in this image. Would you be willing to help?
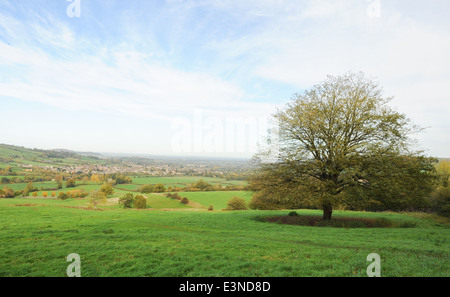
[0,197,450,277]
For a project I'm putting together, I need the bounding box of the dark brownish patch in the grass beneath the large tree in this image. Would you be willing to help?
[263,215,400,228]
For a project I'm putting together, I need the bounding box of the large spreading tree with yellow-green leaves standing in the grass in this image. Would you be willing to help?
[251,73,433,220]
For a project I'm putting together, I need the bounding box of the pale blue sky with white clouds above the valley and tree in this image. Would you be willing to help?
[0,0,450,158]
